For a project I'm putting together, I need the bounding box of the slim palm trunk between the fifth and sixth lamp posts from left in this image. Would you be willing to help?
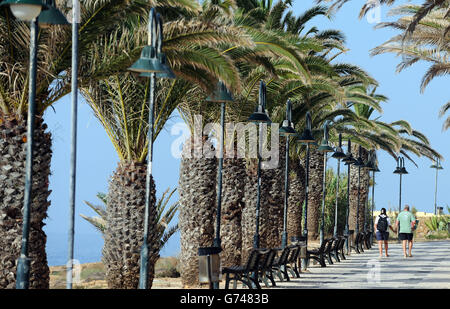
[287,158,305,240]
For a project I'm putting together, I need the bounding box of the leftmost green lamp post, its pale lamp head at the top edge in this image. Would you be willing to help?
[0,0,66,289]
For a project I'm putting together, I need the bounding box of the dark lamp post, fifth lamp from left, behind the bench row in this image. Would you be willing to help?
[279,100,297,248]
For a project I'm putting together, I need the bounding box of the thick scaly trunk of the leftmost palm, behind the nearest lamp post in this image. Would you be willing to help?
[0,118,52,289]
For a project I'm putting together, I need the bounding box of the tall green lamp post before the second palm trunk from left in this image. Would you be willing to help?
[128,8,175,289]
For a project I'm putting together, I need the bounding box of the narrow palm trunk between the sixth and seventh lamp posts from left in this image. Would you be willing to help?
[307,149,323,240]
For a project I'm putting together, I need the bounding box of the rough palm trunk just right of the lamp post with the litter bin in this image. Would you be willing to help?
[220,158,246,267]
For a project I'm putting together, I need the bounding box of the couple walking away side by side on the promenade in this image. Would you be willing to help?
[375,205,417,258]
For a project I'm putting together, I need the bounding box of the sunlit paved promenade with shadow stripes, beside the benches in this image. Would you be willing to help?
[274,241,450,289]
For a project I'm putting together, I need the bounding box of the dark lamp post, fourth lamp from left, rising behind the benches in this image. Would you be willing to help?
[248,81,272,249]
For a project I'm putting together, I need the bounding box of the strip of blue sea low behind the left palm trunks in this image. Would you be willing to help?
[46,232,180,266]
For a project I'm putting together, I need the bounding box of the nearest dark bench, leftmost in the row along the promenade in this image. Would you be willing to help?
[222,249,262,289]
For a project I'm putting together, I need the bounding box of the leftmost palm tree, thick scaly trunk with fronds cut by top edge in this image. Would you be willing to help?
[0,0,196,288]
